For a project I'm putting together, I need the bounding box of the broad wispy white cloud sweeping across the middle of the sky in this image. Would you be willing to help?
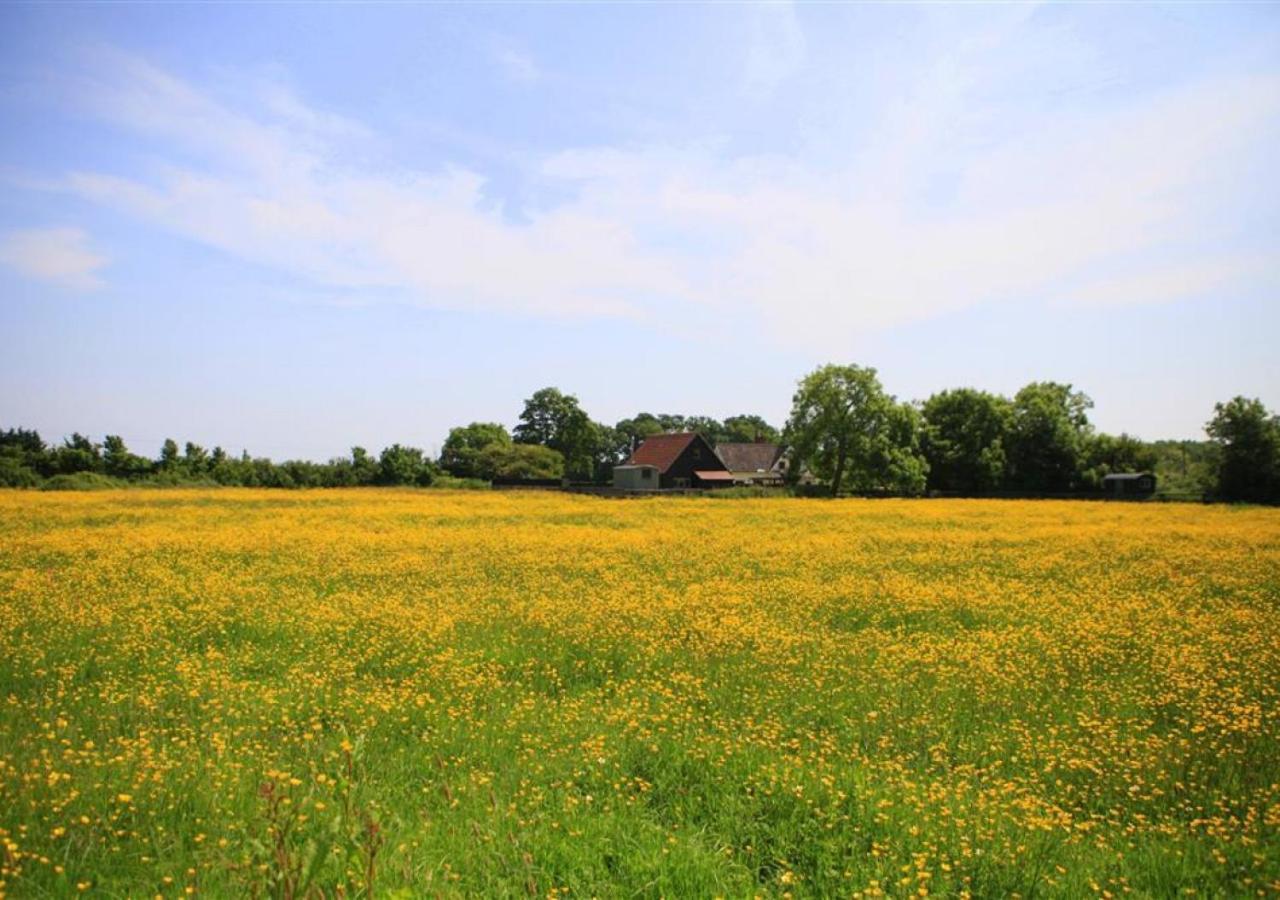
[35,35,1280,348]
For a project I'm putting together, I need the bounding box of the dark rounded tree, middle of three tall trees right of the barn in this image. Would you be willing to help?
[922,388,1012,494]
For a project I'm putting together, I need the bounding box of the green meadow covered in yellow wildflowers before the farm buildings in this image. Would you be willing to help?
[0,490,1280,897]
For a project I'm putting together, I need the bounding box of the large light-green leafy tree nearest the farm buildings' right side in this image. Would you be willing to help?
[783,365,928,495]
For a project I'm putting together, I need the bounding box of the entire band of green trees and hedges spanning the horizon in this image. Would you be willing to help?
[0,365,1280,502]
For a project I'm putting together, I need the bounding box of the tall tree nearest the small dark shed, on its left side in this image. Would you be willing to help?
[1006,382,1093,493]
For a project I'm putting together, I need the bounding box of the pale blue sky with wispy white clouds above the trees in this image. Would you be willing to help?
[0,4,1280,458]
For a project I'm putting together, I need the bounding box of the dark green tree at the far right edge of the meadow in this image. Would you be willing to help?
[1204,397,1280,503]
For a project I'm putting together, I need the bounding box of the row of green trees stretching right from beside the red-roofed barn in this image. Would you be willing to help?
[783,365,1280,502]
